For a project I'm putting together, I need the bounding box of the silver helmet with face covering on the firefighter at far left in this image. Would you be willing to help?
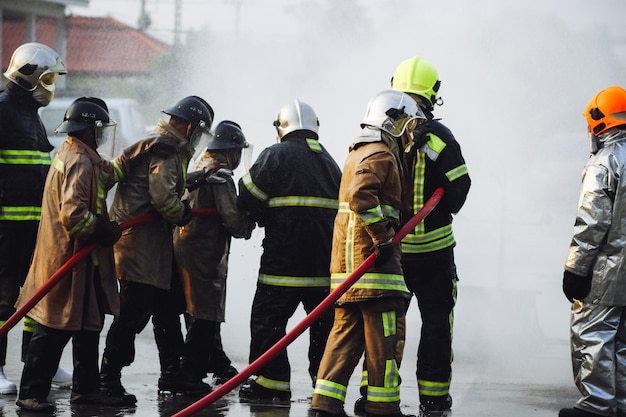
[4,42,67,91]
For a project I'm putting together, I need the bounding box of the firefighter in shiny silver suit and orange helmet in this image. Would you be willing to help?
[559,86,626,417]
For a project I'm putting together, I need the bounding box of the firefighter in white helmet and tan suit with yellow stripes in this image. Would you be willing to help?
[311,90,425,417]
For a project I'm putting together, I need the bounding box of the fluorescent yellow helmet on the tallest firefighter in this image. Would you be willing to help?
[391,56,441,105]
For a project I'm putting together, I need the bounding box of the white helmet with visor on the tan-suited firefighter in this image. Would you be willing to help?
[361,90,426,138]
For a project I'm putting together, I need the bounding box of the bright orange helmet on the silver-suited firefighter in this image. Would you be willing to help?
[583,86,626,136]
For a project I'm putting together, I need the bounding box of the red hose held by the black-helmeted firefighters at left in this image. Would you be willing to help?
[0,208,217,337]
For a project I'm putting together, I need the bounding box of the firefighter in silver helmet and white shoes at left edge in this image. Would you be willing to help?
[0,43,72,394]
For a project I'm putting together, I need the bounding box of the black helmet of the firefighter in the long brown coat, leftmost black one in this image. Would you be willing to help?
[55,97,116,133]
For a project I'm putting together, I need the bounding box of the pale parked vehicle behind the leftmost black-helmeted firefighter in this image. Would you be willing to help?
[39,97,146,159]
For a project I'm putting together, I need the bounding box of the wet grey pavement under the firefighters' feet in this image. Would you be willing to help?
[0,286,578,417]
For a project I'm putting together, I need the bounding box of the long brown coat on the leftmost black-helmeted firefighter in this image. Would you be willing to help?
[16,136,121,331]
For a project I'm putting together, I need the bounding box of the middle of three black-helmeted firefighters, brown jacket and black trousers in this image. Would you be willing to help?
[100,96,213,403]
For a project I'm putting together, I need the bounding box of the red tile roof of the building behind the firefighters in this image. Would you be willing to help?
[2,16,169,76]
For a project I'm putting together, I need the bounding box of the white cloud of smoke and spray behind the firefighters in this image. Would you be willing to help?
[83,0,626,384]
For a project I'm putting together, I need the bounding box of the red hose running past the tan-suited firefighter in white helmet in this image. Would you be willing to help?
[172,187,444,417]
